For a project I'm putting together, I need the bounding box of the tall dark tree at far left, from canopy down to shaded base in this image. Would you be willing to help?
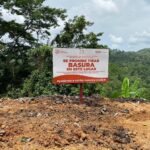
[0,0,66,92]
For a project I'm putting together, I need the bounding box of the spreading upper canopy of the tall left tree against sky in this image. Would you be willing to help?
[0,0,65,51]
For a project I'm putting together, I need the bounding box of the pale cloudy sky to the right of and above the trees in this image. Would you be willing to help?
[46,0,150,51]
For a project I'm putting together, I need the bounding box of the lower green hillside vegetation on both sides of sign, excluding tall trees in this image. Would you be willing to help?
[0,46,150,99]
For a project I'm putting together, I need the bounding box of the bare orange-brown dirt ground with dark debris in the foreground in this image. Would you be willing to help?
[0,96,150,150]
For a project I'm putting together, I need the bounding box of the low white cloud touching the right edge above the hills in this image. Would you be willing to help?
[129,30,150,44]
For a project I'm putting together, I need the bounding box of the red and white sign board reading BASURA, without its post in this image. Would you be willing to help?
[53,48,109,84]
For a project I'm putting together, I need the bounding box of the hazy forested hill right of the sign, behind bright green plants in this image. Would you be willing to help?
[110,48,150,99]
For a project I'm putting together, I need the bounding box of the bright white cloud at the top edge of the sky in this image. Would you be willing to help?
[68,0,119,20]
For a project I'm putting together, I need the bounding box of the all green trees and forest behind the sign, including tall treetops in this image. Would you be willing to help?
[0,0,150,99]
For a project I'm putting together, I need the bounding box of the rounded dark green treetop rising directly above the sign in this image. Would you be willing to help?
[52,16,105,48]
